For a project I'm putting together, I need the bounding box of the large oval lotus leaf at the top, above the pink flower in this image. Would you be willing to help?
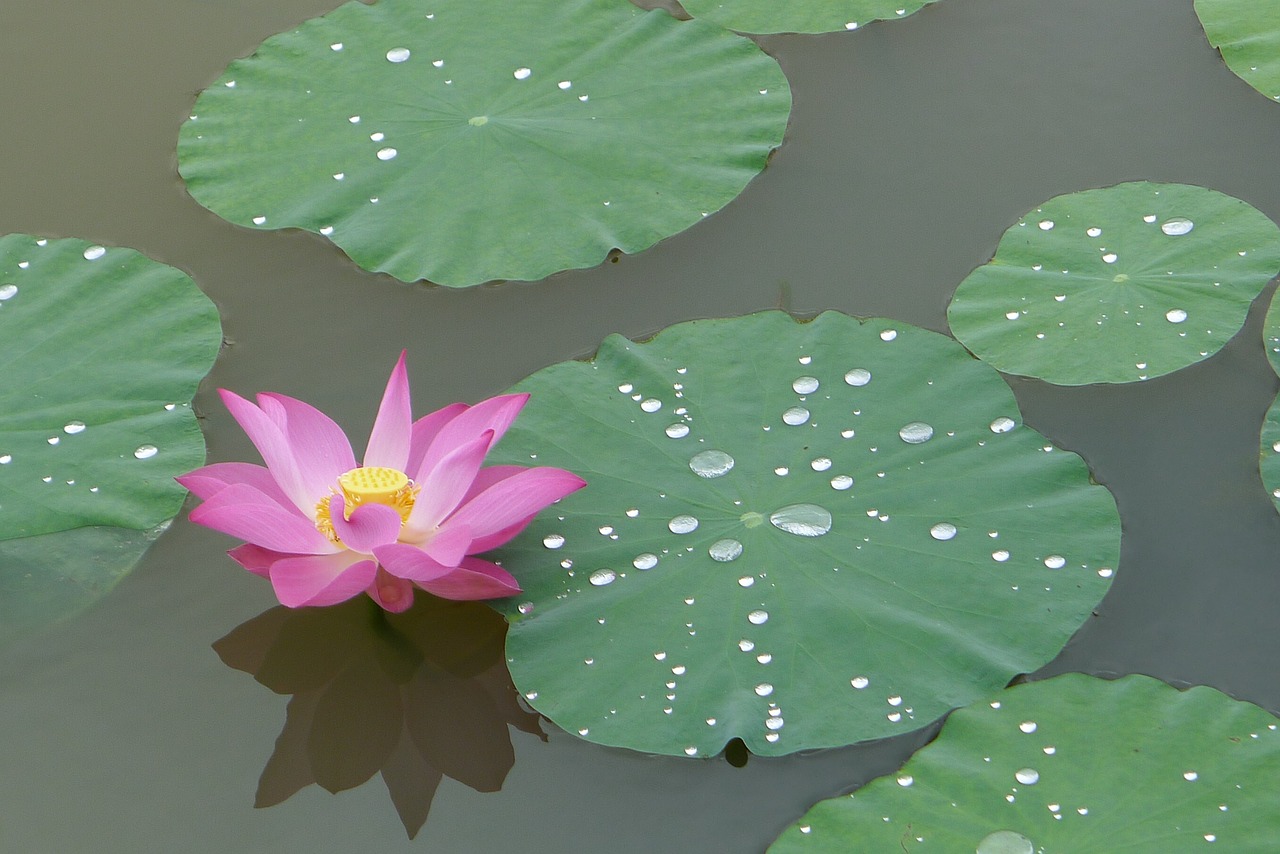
[178,0,791,286]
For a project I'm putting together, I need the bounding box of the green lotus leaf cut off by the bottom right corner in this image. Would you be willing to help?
[769,673,1280,854]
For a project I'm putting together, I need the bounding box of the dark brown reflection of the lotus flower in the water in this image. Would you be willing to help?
[214,597,545,839]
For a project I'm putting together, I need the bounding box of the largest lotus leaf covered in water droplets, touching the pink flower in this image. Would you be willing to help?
[483,311,1120,755]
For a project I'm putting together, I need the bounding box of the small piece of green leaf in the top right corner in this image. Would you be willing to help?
[1196,0,1280,100]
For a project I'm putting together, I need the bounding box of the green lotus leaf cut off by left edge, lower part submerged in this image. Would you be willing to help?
[0,234,221,640]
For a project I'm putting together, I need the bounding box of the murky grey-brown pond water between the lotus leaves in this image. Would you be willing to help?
[0,0,1280,853]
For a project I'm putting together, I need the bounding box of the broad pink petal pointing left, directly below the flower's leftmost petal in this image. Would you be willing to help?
[189,484,338,554]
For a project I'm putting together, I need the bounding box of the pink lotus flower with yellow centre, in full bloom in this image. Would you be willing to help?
[178,353,586,612]
